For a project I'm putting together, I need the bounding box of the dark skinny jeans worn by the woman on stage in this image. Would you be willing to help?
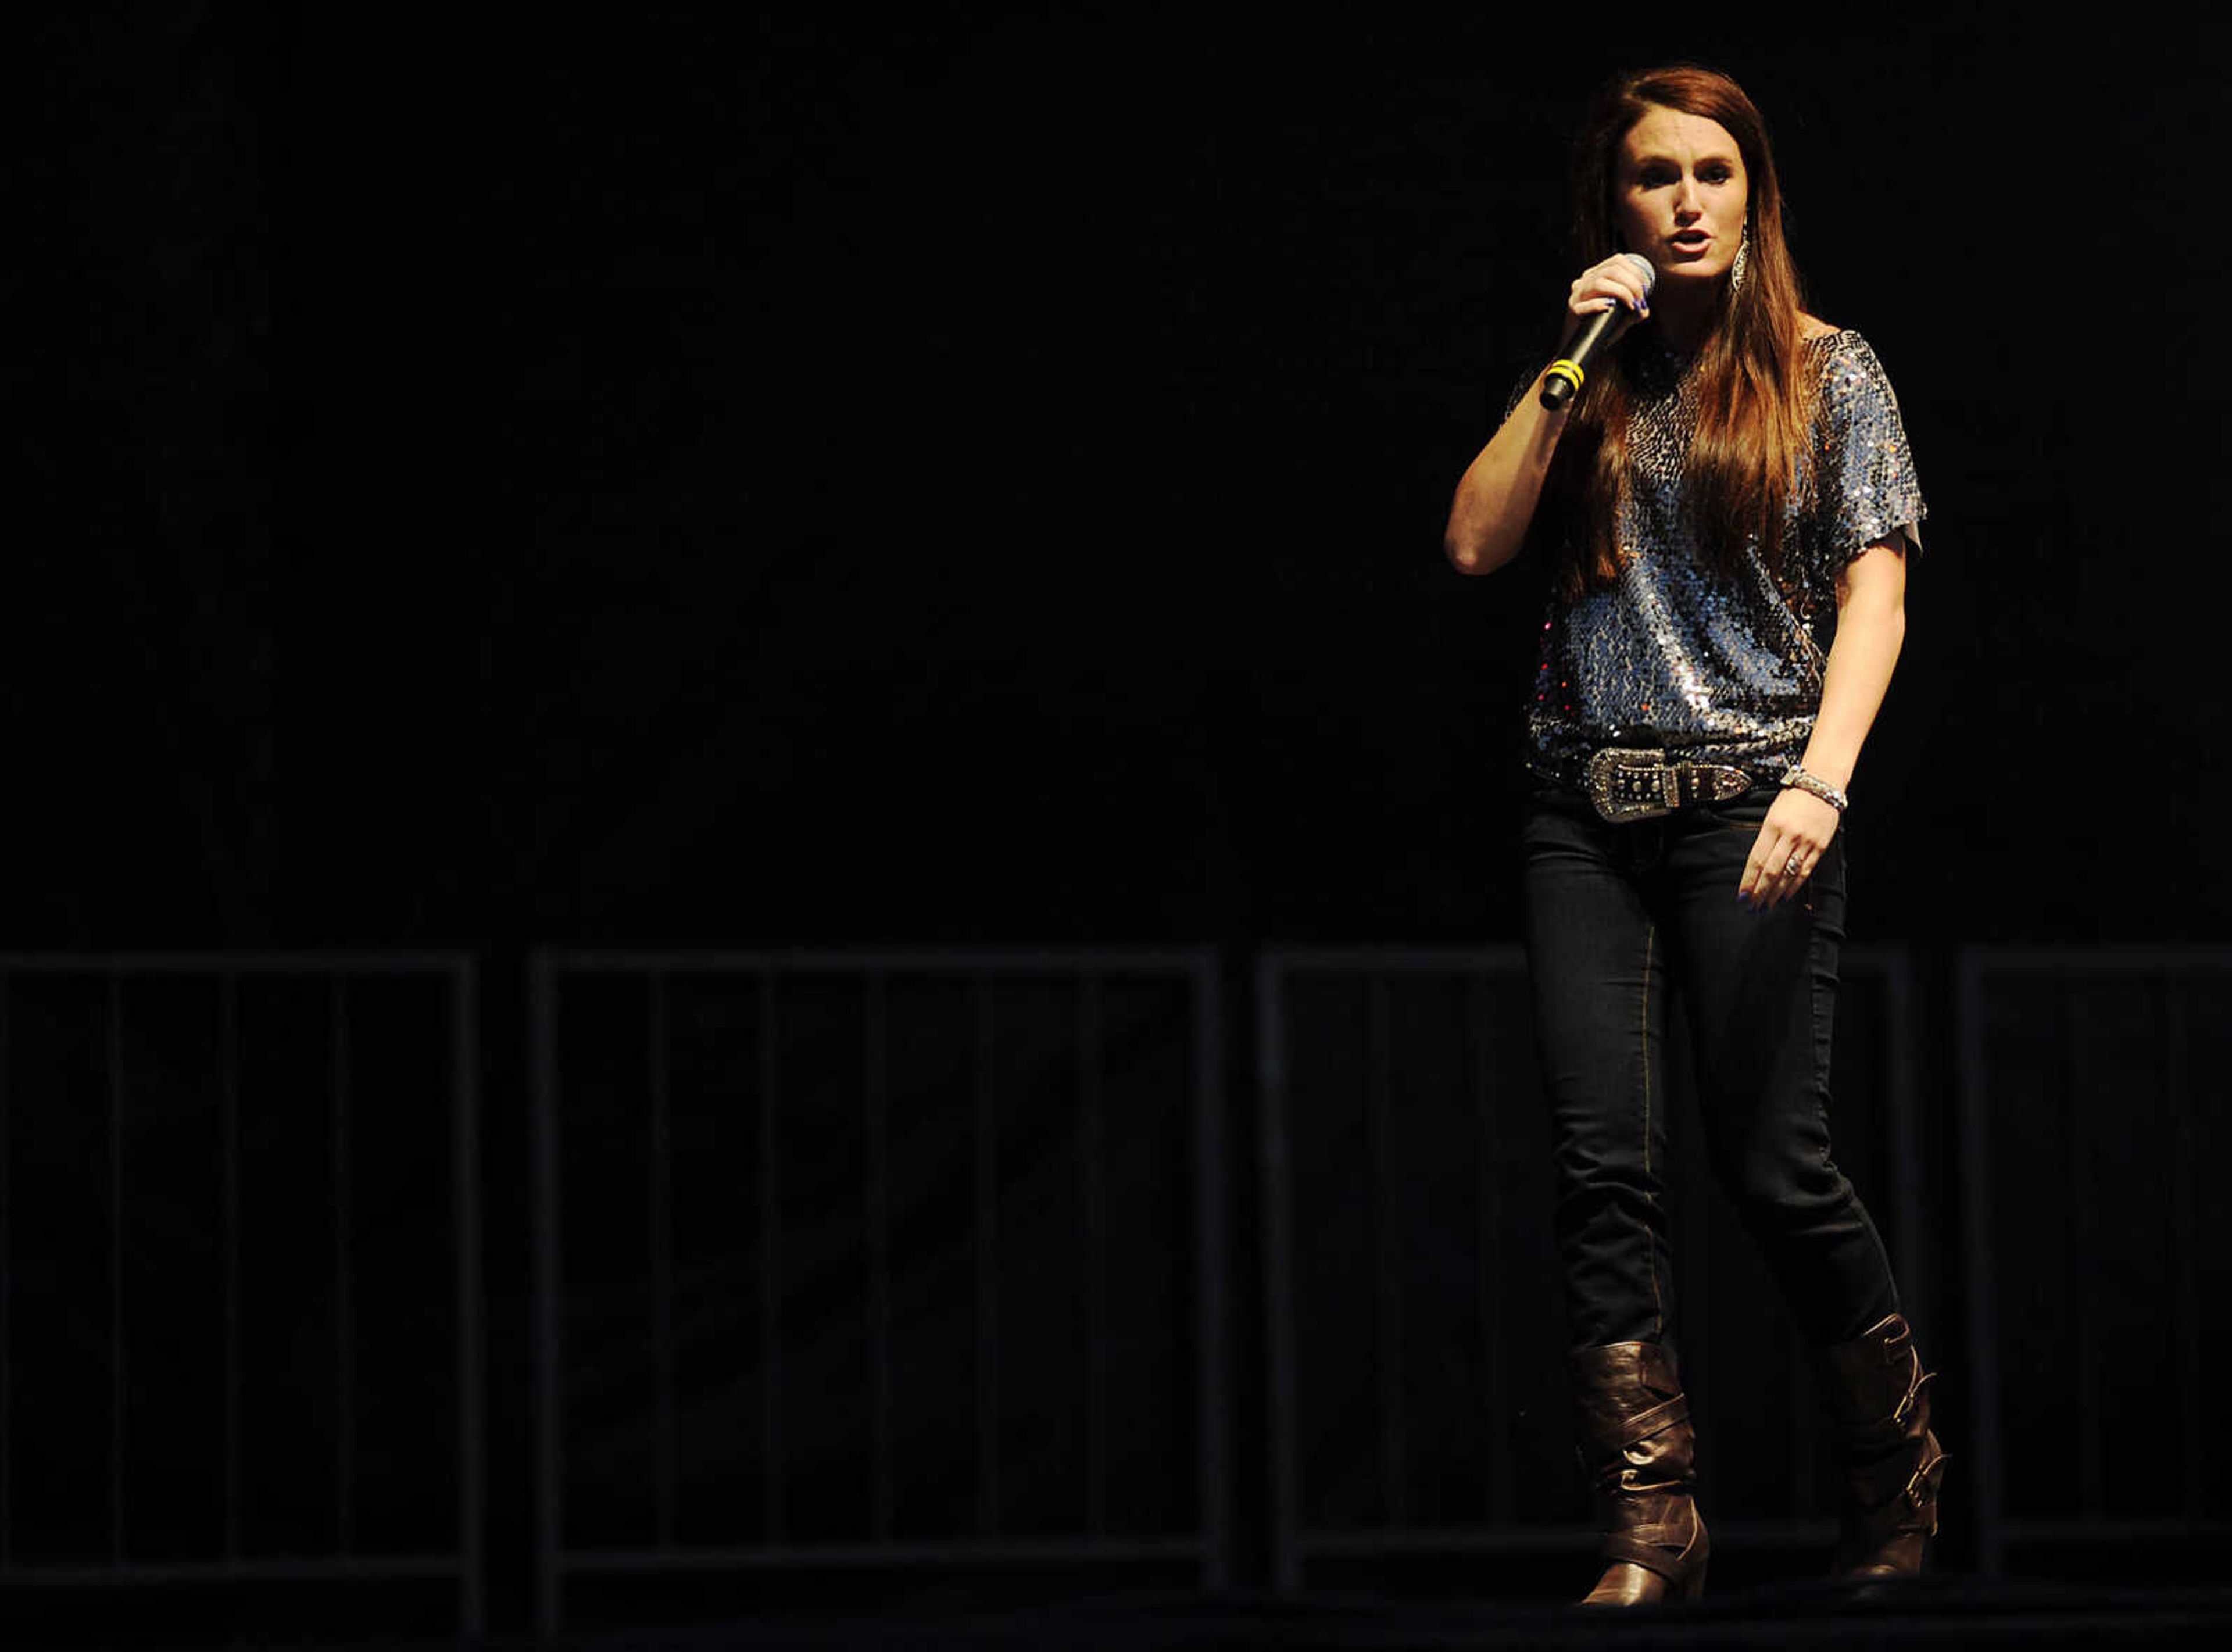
[1522,788,1900,1351]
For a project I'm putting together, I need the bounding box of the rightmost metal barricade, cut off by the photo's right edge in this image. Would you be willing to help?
[1955,946,2232,1578]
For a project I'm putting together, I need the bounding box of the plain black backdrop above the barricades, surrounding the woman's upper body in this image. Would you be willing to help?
[0,5,2227,946]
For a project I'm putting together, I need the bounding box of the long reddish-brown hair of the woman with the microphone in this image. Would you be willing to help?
[1558,63,1815,598]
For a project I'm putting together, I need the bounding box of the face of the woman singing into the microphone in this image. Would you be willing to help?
[1611,107,1752,281]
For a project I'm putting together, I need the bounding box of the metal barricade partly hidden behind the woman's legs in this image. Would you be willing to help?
[1257,946,1937,1589]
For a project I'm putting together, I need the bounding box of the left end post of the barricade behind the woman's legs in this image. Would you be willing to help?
[1257,951,1301,1589]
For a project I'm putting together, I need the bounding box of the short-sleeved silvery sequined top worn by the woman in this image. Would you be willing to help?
[1527,330,1924,781]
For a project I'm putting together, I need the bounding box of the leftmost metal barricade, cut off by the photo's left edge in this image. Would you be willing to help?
[0,953,484,1634]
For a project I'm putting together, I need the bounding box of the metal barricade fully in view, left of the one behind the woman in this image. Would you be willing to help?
[531,951,1230,1634]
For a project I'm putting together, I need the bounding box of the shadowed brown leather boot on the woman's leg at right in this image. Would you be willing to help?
[1823,1315,1946,1583]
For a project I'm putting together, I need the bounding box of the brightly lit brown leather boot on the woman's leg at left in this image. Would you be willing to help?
[1573,1342,1712,1605]
